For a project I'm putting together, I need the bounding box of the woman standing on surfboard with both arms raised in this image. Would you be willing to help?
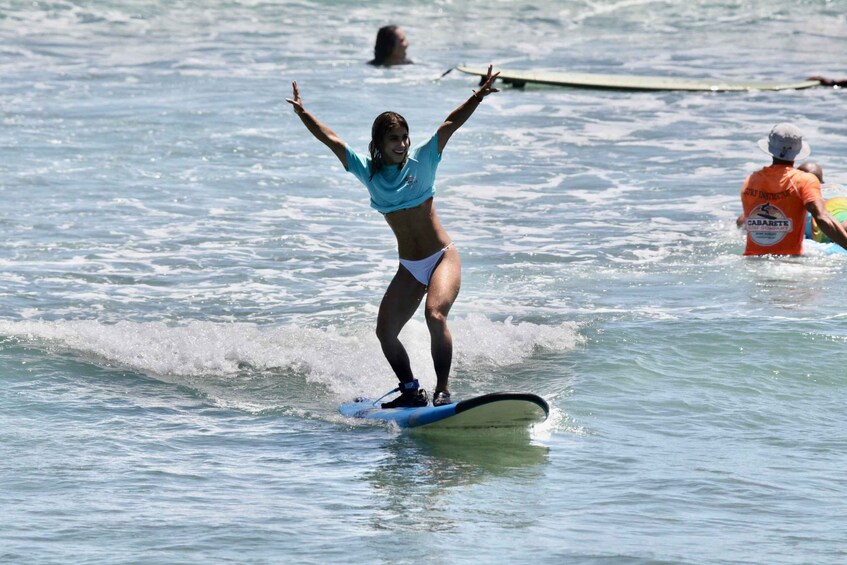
[286,66,499,408]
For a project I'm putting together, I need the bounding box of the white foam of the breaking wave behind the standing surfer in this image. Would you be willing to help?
[0,315,582,405]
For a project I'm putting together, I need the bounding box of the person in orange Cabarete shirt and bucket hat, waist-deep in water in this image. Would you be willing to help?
[741,123,847,255]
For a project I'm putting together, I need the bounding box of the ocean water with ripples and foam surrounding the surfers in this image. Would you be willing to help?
[0,0,847,565]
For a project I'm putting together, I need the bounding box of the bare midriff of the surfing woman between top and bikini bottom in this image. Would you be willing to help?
[385,198,451,261]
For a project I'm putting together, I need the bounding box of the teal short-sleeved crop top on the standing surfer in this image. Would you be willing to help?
[345,132,441,214]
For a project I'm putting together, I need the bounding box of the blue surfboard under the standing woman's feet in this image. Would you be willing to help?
[338,392,550,429]
